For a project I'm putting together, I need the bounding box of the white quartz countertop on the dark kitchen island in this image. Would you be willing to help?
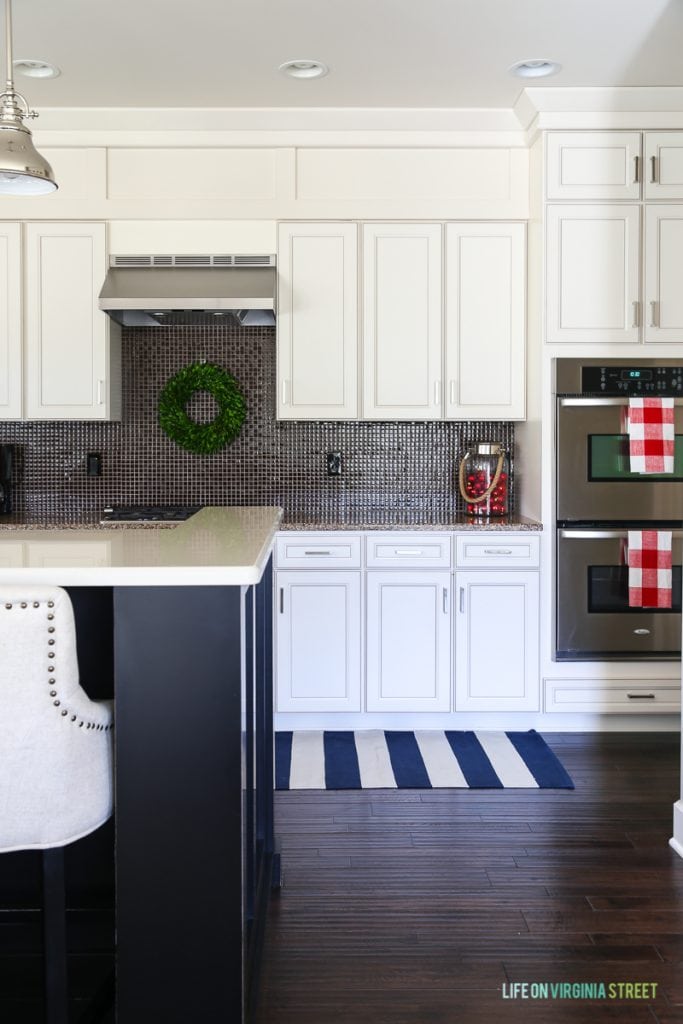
[0,506,282,587]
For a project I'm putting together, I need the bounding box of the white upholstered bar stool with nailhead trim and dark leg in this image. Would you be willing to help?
[0,585,113,1024]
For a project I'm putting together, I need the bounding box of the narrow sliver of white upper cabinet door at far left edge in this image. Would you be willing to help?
[0,224,23,420]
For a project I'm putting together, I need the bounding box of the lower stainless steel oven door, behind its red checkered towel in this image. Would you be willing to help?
[556,527,683,662]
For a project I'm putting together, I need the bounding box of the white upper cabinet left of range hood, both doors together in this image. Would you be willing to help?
[0,221,121,420]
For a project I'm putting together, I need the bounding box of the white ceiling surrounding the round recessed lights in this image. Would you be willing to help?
[7,0,683,110]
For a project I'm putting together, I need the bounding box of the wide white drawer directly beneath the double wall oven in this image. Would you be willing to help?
[545,679,681,715]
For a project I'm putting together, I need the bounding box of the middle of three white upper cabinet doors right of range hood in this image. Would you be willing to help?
[362,224,442,420]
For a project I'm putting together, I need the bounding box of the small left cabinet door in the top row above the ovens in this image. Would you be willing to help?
[546,131,642,200]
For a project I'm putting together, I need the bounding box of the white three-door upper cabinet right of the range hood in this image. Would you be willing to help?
[278,222,526,420]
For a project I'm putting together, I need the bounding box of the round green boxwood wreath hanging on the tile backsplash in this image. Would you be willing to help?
[159,362,247,455]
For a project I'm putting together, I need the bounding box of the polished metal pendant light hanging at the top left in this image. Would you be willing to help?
[0,0,57,196]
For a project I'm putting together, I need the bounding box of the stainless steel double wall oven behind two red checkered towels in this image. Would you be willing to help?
[556,359,683,660]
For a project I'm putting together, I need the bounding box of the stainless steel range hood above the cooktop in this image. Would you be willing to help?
[99,255,275,327]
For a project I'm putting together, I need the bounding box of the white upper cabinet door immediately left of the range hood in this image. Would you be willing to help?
[26,222,117,420]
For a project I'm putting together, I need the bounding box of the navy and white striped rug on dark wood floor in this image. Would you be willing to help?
[275,729,573,790]
